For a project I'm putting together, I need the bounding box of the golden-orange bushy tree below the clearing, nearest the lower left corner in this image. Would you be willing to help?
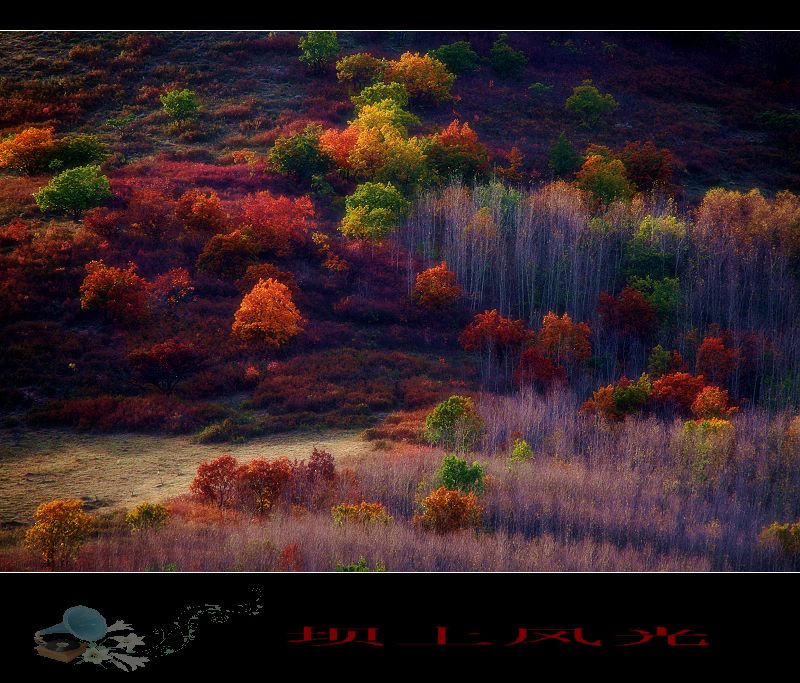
[25,499,93,569]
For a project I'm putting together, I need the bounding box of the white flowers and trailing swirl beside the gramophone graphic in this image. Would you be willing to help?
[34,587,263,671]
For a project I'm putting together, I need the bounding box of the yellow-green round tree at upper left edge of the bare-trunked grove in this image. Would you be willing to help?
[339,183,411,239]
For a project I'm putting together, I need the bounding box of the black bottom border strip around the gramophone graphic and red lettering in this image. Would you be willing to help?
[2,573,796,680]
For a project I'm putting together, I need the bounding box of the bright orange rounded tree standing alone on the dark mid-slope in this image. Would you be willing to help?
[232,278,303,349]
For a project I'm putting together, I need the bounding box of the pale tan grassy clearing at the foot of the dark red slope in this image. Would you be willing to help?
[0,429,372,524]
